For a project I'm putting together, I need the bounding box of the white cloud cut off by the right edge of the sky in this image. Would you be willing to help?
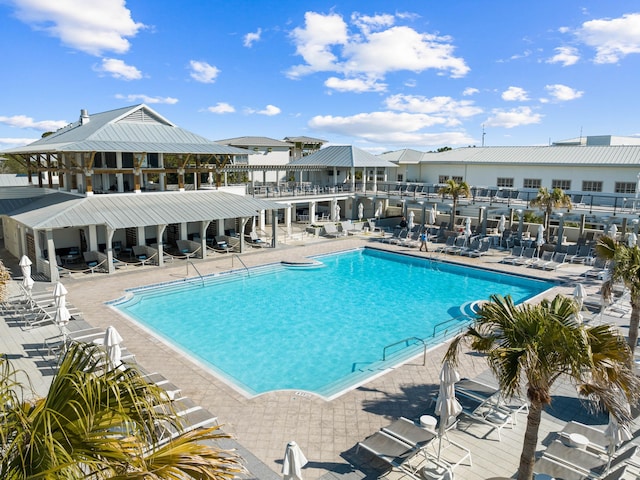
[576,13,640,63]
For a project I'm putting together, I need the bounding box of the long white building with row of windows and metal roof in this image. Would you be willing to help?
[388,145,640,196]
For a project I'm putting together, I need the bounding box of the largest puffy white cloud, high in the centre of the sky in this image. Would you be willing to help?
[287,12,469,80]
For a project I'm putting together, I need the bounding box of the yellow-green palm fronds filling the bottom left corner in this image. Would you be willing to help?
[0,345,244,480]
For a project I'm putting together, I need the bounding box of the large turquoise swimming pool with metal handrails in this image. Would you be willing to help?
[113,248,553,398]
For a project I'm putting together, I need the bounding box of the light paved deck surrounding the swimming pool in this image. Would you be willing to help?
[0,235,636,480]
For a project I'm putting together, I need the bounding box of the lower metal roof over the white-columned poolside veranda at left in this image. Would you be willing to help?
[6,190,284,229]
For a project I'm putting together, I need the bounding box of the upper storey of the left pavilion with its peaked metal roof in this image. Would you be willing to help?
[2,104,254,195]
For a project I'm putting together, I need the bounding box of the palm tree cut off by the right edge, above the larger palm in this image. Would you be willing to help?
[596,236,640,352]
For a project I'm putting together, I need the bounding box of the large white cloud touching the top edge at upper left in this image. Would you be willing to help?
[13,0,144,55]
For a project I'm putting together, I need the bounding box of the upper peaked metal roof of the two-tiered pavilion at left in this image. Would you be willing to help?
[3,104,247,155]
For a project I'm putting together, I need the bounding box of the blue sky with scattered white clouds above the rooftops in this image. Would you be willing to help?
[0,0,640,153]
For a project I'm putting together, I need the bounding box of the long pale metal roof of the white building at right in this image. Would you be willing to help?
[421,145,640,167]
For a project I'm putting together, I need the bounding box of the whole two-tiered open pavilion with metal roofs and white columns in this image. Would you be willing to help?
[0,105,288,281]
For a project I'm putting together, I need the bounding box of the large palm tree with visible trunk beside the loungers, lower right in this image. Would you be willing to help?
[445,295,640,480]
